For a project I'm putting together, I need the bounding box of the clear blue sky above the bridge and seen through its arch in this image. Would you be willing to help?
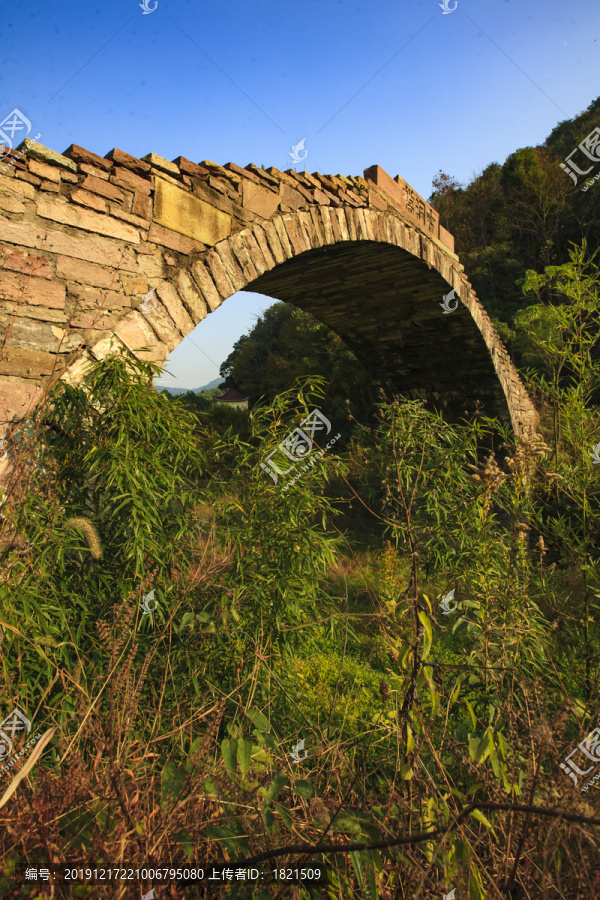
[0,0,600,387]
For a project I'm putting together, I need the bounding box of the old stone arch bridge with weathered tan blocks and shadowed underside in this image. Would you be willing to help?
[0,139,537,435]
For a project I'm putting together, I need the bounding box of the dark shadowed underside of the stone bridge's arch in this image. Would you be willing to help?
[245,241,511,422]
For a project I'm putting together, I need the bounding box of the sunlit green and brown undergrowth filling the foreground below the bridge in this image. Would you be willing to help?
[0,244,600,900]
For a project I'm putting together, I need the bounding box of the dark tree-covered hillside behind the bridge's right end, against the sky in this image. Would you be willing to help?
[429,98,600,362]
